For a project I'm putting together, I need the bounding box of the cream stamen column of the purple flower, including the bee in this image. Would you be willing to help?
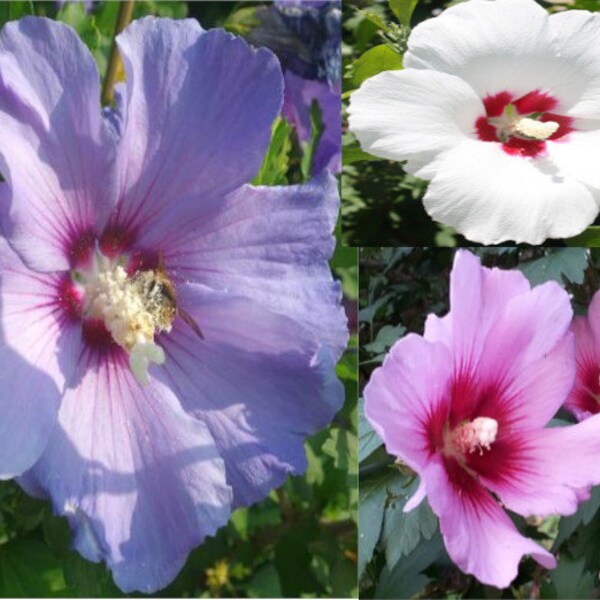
[74,251,177,384]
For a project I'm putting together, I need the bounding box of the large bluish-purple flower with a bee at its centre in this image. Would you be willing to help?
[0,17,347,592]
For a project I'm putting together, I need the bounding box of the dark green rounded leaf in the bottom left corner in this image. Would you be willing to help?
[0,539,66,598]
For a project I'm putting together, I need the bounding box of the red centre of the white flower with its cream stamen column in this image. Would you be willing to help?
[475,90,574,158]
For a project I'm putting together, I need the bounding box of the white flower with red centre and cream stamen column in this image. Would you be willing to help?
[349,0,600,244]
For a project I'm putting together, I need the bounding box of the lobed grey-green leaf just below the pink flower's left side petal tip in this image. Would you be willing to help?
[381,477,438,566]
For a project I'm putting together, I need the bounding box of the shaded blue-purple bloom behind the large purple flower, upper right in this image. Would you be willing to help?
[248,0,342,174]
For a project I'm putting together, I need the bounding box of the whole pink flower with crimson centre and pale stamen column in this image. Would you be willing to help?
[365,251,600,587]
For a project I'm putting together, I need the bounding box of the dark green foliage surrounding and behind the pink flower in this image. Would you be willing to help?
[358,247,600,599]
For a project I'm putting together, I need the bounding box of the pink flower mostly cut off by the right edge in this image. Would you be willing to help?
[565,292,600,421]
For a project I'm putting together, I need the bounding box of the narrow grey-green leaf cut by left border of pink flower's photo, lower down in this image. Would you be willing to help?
[358,474,389,577]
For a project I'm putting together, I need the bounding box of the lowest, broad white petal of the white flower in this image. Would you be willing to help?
[424,140,598,244]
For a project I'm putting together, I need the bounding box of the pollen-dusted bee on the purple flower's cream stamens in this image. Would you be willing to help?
[131,250,204,339]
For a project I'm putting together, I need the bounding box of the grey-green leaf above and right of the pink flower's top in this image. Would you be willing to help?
[519,248,587,285]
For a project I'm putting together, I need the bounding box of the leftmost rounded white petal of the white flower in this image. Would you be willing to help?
[348,69,485,168]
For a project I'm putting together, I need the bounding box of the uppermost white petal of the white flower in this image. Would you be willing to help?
[404,0,586,108]
